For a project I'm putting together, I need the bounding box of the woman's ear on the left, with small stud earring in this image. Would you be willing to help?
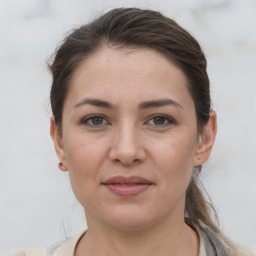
[50,117,67,171]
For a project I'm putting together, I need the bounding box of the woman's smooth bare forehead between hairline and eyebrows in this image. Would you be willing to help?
[67,47,193,107]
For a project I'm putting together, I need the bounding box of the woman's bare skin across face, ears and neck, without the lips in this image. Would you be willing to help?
[51,47,216,256]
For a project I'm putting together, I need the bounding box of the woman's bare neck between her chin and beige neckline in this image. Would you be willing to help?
[75,215,199,256]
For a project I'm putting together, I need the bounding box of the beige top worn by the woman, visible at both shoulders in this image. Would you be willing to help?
[15,228,256,256]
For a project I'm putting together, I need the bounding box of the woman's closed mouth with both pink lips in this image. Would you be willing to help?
[102,176,154,196]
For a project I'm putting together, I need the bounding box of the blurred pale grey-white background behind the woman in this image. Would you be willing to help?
[0,0,256,256]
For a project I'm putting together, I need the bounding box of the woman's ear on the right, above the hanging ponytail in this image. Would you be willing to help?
[194,111,217,166]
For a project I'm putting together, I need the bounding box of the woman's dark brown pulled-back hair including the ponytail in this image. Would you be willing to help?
[49,8,221,234]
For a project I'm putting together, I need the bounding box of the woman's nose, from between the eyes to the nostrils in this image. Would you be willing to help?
[109,122,146,166]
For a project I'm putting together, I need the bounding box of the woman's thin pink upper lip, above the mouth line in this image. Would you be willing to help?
[102,176,153,185]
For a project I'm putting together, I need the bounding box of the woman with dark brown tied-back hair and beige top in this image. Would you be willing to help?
[17,8,255,256]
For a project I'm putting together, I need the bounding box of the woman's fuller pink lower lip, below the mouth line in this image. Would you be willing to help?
[105,184,152,196]
